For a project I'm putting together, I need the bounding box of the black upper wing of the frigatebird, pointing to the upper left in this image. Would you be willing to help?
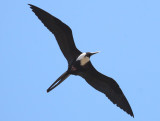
[29,4,81,64]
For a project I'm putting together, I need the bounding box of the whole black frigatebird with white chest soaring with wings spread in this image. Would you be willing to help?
[29,4,134,117]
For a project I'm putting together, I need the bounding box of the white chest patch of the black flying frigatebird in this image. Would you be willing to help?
[76,53,90,66]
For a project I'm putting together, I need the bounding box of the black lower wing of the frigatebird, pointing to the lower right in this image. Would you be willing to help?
[78,62,134,117]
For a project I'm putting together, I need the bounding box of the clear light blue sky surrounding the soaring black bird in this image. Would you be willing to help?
[0,0,160,121]
